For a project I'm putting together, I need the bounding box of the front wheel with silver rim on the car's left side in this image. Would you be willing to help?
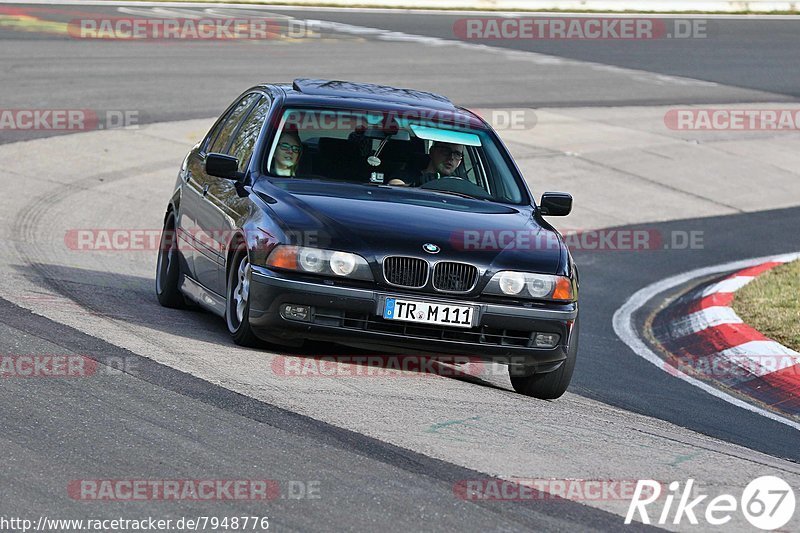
[225,244,261,347]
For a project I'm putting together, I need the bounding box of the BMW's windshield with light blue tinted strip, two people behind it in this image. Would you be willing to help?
[265,108,525,204]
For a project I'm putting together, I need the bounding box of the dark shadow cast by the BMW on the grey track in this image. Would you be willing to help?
[18,264,508,391]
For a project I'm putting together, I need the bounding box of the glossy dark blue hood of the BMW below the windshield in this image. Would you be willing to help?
[262,182,565,274]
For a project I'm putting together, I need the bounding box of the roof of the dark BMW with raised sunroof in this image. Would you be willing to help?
[253,78,484,126]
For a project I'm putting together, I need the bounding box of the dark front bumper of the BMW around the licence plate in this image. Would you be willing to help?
[250,267,578,371]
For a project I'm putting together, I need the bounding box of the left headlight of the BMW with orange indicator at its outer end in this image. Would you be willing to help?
[266,244,373,281]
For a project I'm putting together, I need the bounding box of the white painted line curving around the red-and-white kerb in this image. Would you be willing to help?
[613,253,800,430]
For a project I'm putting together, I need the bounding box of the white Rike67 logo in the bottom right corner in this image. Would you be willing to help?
[625,476,795,531]
